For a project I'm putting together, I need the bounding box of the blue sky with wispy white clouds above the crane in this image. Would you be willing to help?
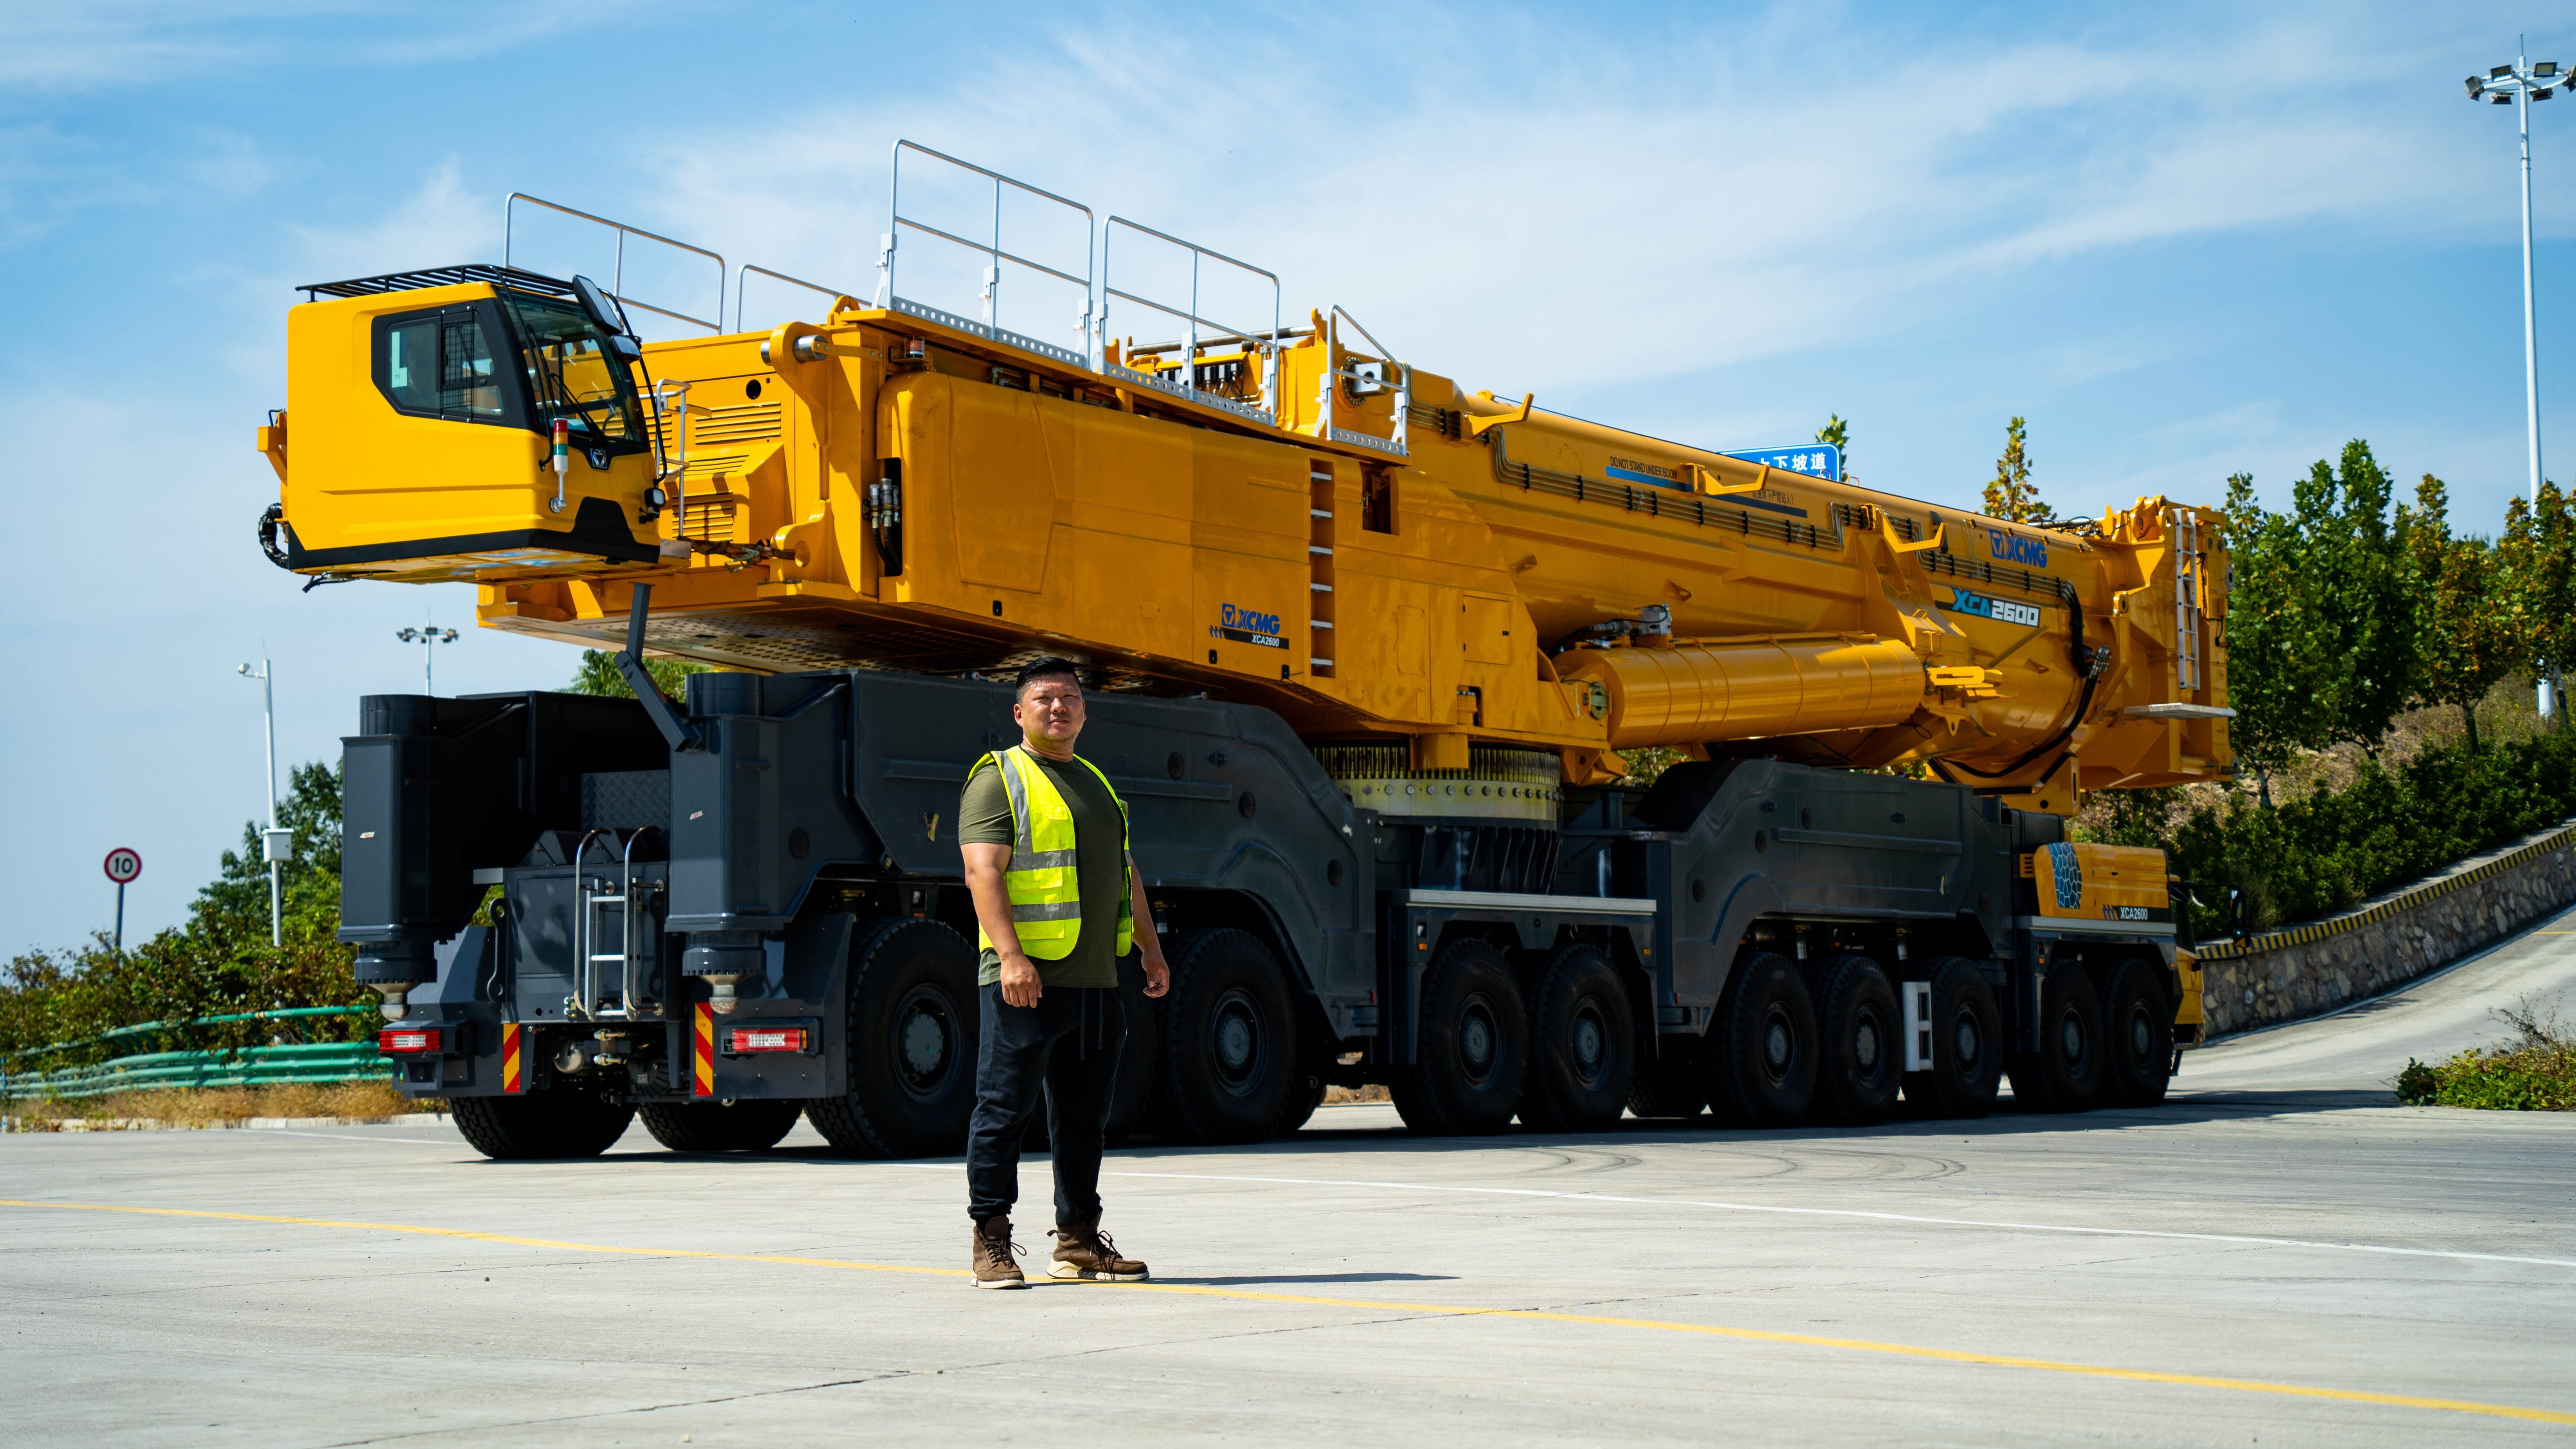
[0,0,2576,951]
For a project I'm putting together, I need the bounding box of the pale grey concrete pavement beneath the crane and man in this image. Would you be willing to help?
[0,907,2576,1446]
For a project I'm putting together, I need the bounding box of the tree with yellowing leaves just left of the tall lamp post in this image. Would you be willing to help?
[2398,472,2530,750]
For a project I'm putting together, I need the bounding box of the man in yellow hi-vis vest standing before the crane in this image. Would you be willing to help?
[958,660,1172,1289]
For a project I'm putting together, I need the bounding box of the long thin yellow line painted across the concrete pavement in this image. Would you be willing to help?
[0,1199,2576,1423]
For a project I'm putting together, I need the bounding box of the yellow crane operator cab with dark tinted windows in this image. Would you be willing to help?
[260,266,665,583]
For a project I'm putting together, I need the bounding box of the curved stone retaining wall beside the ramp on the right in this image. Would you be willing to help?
[2197,823,2576,1036]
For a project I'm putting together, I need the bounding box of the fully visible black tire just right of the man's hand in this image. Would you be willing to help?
[1157,928,1298,1142]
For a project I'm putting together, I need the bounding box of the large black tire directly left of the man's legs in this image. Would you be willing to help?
[806,918,981,1157]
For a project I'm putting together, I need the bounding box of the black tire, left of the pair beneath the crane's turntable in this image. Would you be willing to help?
[1386,941,1530,1137]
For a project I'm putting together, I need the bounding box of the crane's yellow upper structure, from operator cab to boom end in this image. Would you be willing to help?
[260,196,2231,815]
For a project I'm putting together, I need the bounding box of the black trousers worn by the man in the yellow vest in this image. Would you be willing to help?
[966,985,1126,1225]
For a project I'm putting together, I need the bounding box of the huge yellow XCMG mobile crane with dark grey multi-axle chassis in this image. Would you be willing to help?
[260,142,2228,1152]
